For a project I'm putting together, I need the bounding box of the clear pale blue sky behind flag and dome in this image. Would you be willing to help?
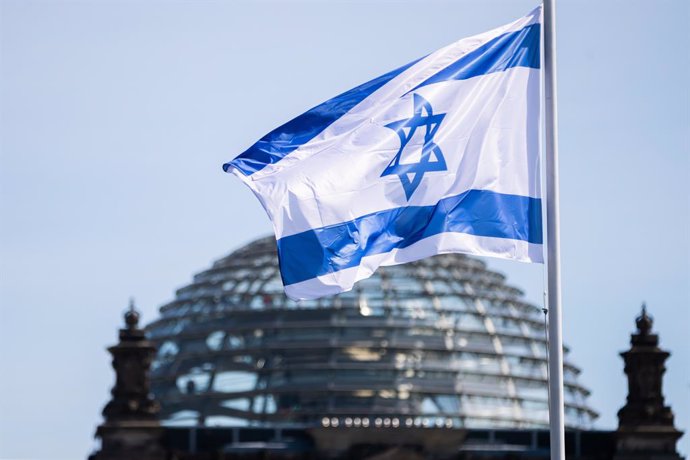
[0,0,690,459]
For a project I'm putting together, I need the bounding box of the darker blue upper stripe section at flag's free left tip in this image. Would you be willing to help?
[223,59,419,176]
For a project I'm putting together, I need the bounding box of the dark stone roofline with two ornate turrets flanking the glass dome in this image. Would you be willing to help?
[90,307,683,460]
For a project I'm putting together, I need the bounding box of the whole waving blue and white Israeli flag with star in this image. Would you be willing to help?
[223,7,542,299]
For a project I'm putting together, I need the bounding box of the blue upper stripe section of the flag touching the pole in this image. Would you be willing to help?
[408,24,540,92]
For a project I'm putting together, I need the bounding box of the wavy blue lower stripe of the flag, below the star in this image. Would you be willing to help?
[278,190,542,286]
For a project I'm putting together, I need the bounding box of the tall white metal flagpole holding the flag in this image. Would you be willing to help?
[544,0,565,460]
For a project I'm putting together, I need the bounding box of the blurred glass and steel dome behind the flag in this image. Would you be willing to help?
[147,237,597,429]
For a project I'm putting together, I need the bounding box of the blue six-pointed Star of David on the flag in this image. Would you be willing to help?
[381,93,448,201]
